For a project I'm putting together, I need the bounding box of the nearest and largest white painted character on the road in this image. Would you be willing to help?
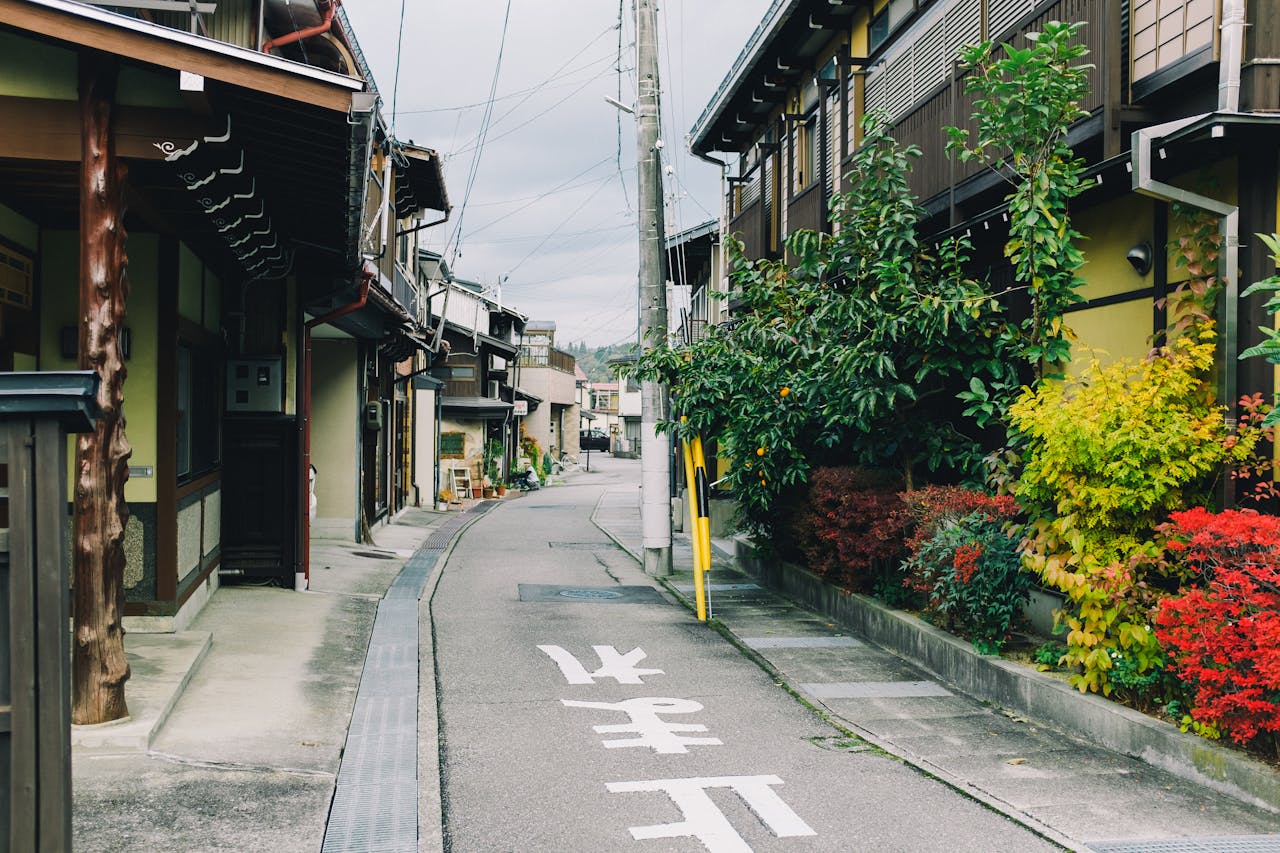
[608,776,817,853]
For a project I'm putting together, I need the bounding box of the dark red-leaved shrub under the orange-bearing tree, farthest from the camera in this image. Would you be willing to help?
[791,467,904,589]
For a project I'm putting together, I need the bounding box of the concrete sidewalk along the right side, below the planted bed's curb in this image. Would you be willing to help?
[594,487,1280,853]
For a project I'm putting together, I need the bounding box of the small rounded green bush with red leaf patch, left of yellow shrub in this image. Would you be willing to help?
[904,512,1032,654]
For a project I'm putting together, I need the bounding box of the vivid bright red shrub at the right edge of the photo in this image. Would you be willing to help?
[1156,508,1280,749]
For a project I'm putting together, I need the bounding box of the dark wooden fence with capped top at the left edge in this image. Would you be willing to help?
[0,371,99,852]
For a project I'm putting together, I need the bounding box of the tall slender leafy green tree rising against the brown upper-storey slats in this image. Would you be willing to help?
[946,20,1092,369]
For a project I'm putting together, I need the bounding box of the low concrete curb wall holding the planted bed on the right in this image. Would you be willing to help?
[735,535,1280,812]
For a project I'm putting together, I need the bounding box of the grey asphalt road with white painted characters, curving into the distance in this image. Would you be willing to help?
[431,453,1057,853]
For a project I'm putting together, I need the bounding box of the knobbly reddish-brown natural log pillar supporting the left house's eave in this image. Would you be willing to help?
[72,54,132,725]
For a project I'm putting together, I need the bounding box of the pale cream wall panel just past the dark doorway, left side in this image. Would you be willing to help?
[311,339,360,538]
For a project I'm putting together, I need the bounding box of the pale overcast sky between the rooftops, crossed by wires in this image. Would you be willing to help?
[343,0,769,348]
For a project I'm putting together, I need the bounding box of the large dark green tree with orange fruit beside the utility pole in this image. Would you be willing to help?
[637,115,1009,528]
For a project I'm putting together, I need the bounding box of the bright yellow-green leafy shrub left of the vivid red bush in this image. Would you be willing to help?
[1010,327,1258,693]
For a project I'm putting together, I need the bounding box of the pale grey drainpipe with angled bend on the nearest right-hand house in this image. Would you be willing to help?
[1130,0,1244,491]
